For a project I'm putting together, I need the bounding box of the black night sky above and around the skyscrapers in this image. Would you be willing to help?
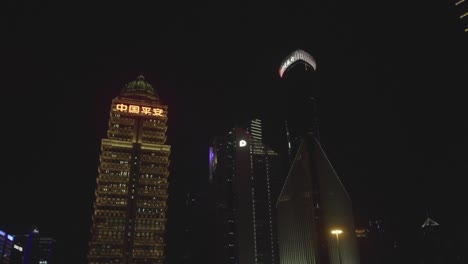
[0,0,468,263]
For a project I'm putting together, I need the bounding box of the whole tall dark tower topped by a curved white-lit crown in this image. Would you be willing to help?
[276,50,360,264]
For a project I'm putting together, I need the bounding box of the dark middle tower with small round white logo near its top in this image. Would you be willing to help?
[209,119,280,264]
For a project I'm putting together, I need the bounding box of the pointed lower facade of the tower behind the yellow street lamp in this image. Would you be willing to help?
[277,133,360,264]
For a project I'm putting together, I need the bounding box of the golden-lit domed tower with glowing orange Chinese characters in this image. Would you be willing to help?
[88,76,170,264]
